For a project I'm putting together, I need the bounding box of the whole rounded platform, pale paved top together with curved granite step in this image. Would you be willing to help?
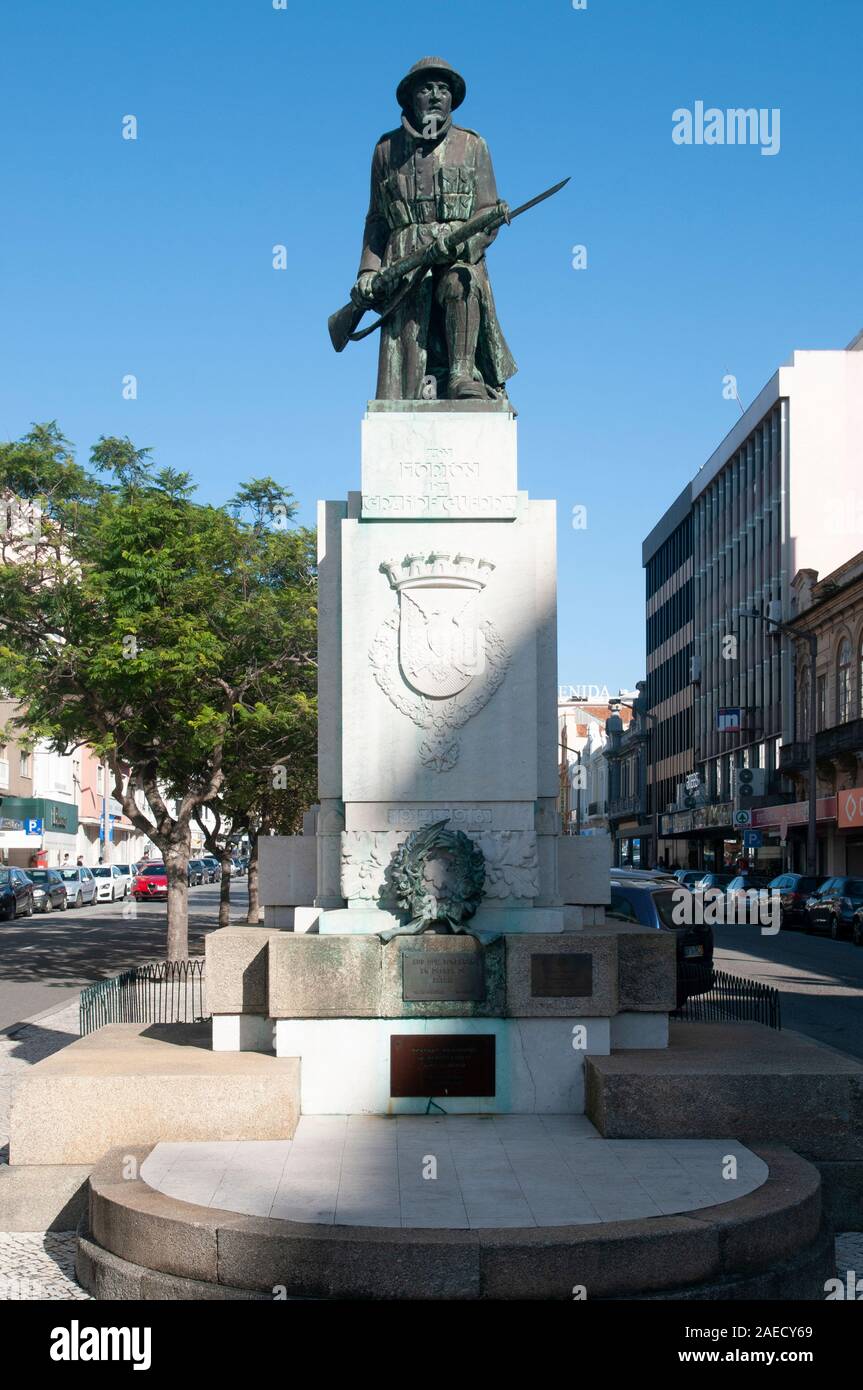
[76,1134,835,1301]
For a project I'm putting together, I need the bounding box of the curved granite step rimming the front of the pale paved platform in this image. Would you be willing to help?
[78,1147,835,1301]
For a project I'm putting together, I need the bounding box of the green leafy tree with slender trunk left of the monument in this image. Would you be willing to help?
[0,427,315,959]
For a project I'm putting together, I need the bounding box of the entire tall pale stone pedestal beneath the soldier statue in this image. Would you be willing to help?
[207,400,650,1113]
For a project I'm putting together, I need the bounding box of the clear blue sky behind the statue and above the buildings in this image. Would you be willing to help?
[0,0,863,688]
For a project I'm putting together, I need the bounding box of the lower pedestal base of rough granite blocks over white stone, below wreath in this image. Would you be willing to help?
[207,924,675,1115]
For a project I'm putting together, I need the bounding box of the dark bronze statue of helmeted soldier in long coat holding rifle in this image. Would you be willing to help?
[350,58,517,400]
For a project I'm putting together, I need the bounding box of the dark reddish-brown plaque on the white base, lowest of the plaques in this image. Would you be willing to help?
[389,1033,495,1098]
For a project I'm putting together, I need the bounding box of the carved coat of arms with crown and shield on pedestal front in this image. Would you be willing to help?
[370,550,510,771]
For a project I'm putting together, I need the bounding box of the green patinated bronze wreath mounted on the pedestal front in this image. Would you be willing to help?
[391,820,485,934]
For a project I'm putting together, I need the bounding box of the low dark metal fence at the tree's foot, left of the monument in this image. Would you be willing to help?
[81,956,207,1037]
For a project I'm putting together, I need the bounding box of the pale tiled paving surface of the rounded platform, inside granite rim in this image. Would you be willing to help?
[140,1115,769,1230]
